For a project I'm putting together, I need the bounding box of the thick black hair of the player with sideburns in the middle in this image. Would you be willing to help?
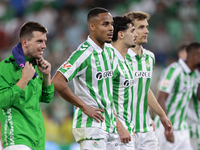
[112,16,133,42]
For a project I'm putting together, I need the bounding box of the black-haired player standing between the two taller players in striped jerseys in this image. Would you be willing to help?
[108,16,137,150]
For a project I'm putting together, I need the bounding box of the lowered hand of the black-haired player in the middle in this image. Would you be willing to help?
[117,119,131,143]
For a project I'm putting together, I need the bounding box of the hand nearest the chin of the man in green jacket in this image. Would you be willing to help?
[36,57,51,76]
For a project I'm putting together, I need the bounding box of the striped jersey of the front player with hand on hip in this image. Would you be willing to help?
[58,37,115,132]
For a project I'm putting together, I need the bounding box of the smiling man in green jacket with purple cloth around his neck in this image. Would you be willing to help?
[0,21,54,150]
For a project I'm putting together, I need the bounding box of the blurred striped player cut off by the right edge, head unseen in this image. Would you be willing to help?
[187,66,200,150]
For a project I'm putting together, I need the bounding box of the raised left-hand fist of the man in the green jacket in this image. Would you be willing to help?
[22,61,35,80]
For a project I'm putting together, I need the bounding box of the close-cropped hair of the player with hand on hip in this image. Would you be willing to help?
[87,7,109,21]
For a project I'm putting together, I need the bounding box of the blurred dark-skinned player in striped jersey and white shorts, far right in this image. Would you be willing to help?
[155,43,200,150]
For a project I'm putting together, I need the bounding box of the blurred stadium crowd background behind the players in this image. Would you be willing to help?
[0,0,200,150]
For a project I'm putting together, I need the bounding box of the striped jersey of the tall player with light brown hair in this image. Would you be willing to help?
[126,48,155,132]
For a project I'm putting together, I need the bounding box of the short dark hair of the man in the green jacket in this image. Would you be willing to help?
[19,21,48,41]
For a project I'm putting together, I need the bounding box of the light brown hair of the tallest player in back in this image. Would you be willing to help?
[125,11,150,20]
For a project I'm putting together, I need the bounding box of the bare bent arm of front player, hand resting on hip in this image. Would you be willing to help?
[52,72,104,122]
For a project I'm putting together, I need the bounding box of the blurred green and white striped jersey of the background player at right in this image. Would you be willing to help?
[155,59,197,130]
